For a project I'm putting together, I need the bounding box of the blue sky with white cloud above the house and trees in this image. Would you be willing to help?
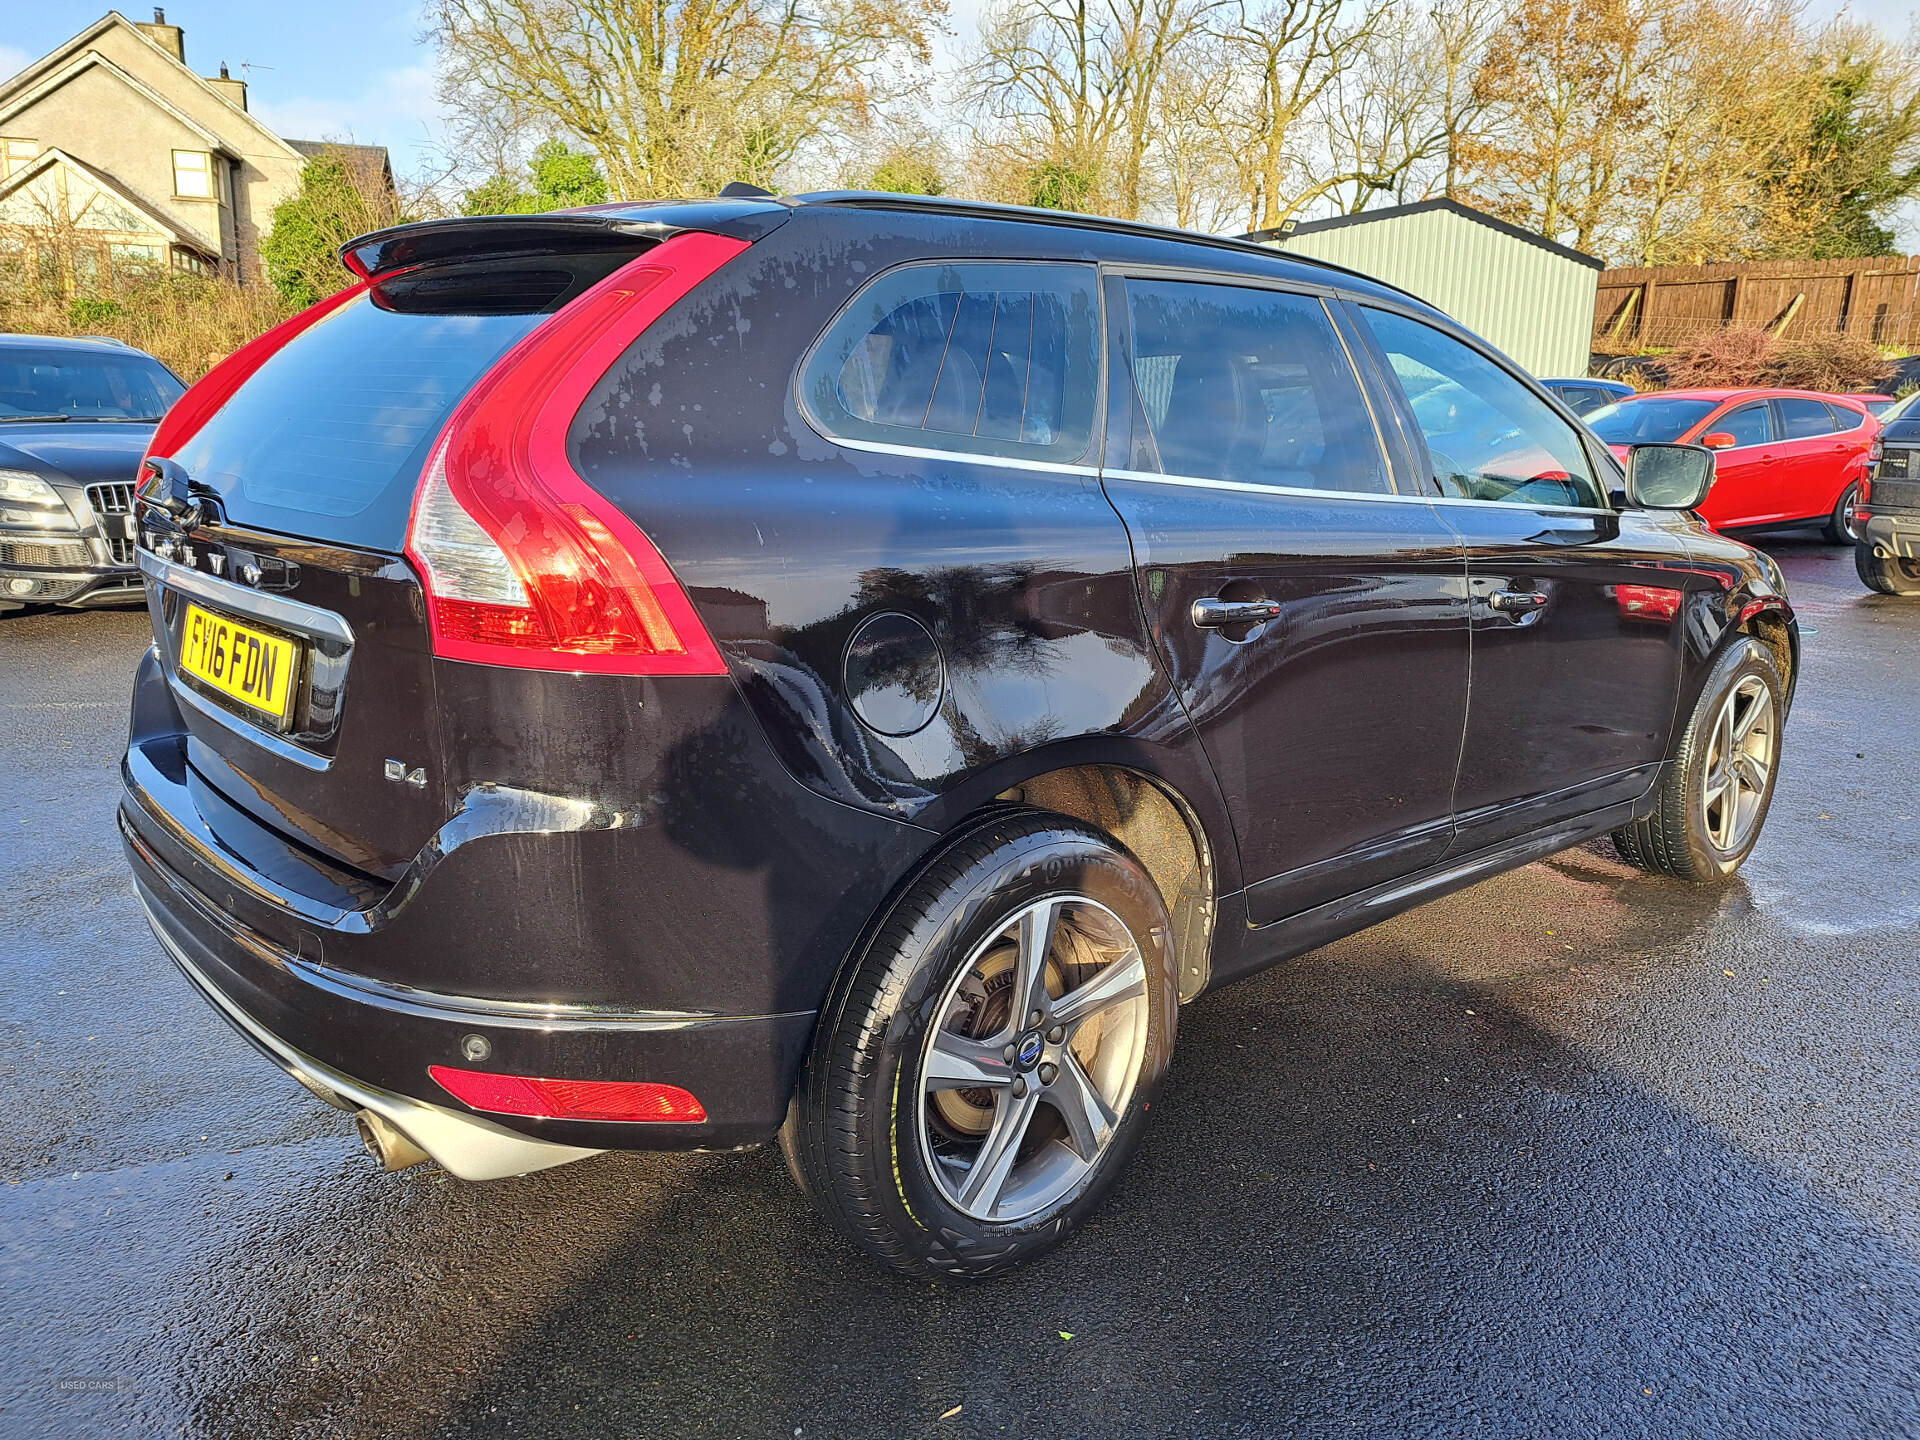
[0,0,1920,250]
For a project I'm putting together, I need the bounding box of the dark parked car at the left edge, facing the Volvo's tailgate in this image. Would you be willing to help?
[0,334,184,611]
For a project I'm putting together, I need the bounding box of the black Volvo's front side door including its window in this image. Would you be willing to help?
[1359,305,1690,854]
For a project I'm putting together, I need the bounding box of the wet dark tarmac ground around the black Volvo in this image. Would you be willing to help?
[0,541,1920,1440]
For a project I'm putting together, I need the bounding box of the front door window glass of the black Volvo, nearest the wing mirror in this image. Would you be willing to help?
[1365,307,1605,509]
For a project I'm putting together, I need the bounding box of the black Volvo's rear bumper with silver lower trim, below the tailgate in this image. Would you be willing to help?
[119,753,814,1179]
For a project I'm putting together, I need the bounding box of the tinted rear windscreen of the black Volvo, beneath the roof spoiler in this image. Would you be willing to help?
[173,252,634,551]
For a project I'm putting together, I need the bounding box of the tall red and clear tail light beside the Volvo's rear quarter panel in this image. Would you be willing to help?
[407,234,747,676]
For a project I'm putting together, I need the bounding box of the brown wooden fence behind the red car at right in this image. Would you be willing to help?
[1594,255,1920,353]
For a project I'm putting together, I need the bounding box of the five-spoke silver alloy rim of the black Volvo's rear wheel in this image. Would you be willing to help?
[918,895,1148,1223]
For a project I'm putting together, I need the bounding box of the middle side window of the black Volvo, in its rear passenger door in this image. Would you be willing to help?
[1127,280,1390,493]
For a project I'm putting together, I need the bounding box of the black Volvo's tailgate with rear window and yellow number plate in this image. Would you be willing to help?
[140,246,637,879]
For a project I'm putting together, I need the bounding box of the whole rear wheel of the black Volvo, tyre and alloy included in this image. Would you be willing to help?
[781,810,1179,1279]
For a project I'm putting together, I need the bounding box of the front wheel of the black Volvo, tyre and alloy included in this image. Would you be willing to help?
[1613,637,1784,881]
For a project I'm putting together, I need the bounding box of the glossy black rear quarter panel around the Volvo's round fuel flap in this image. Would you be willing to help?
[570,207,1238,889]
